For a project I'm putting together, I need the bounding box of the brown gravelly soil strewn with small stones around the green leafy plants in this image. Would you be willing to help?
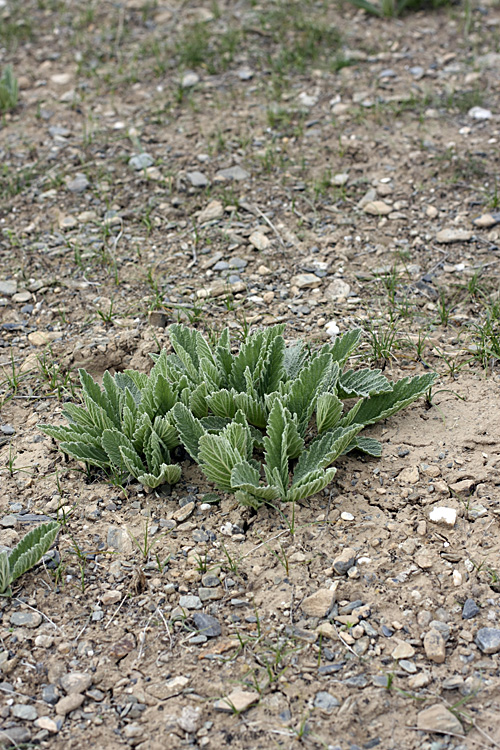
[0,0,500,750]
